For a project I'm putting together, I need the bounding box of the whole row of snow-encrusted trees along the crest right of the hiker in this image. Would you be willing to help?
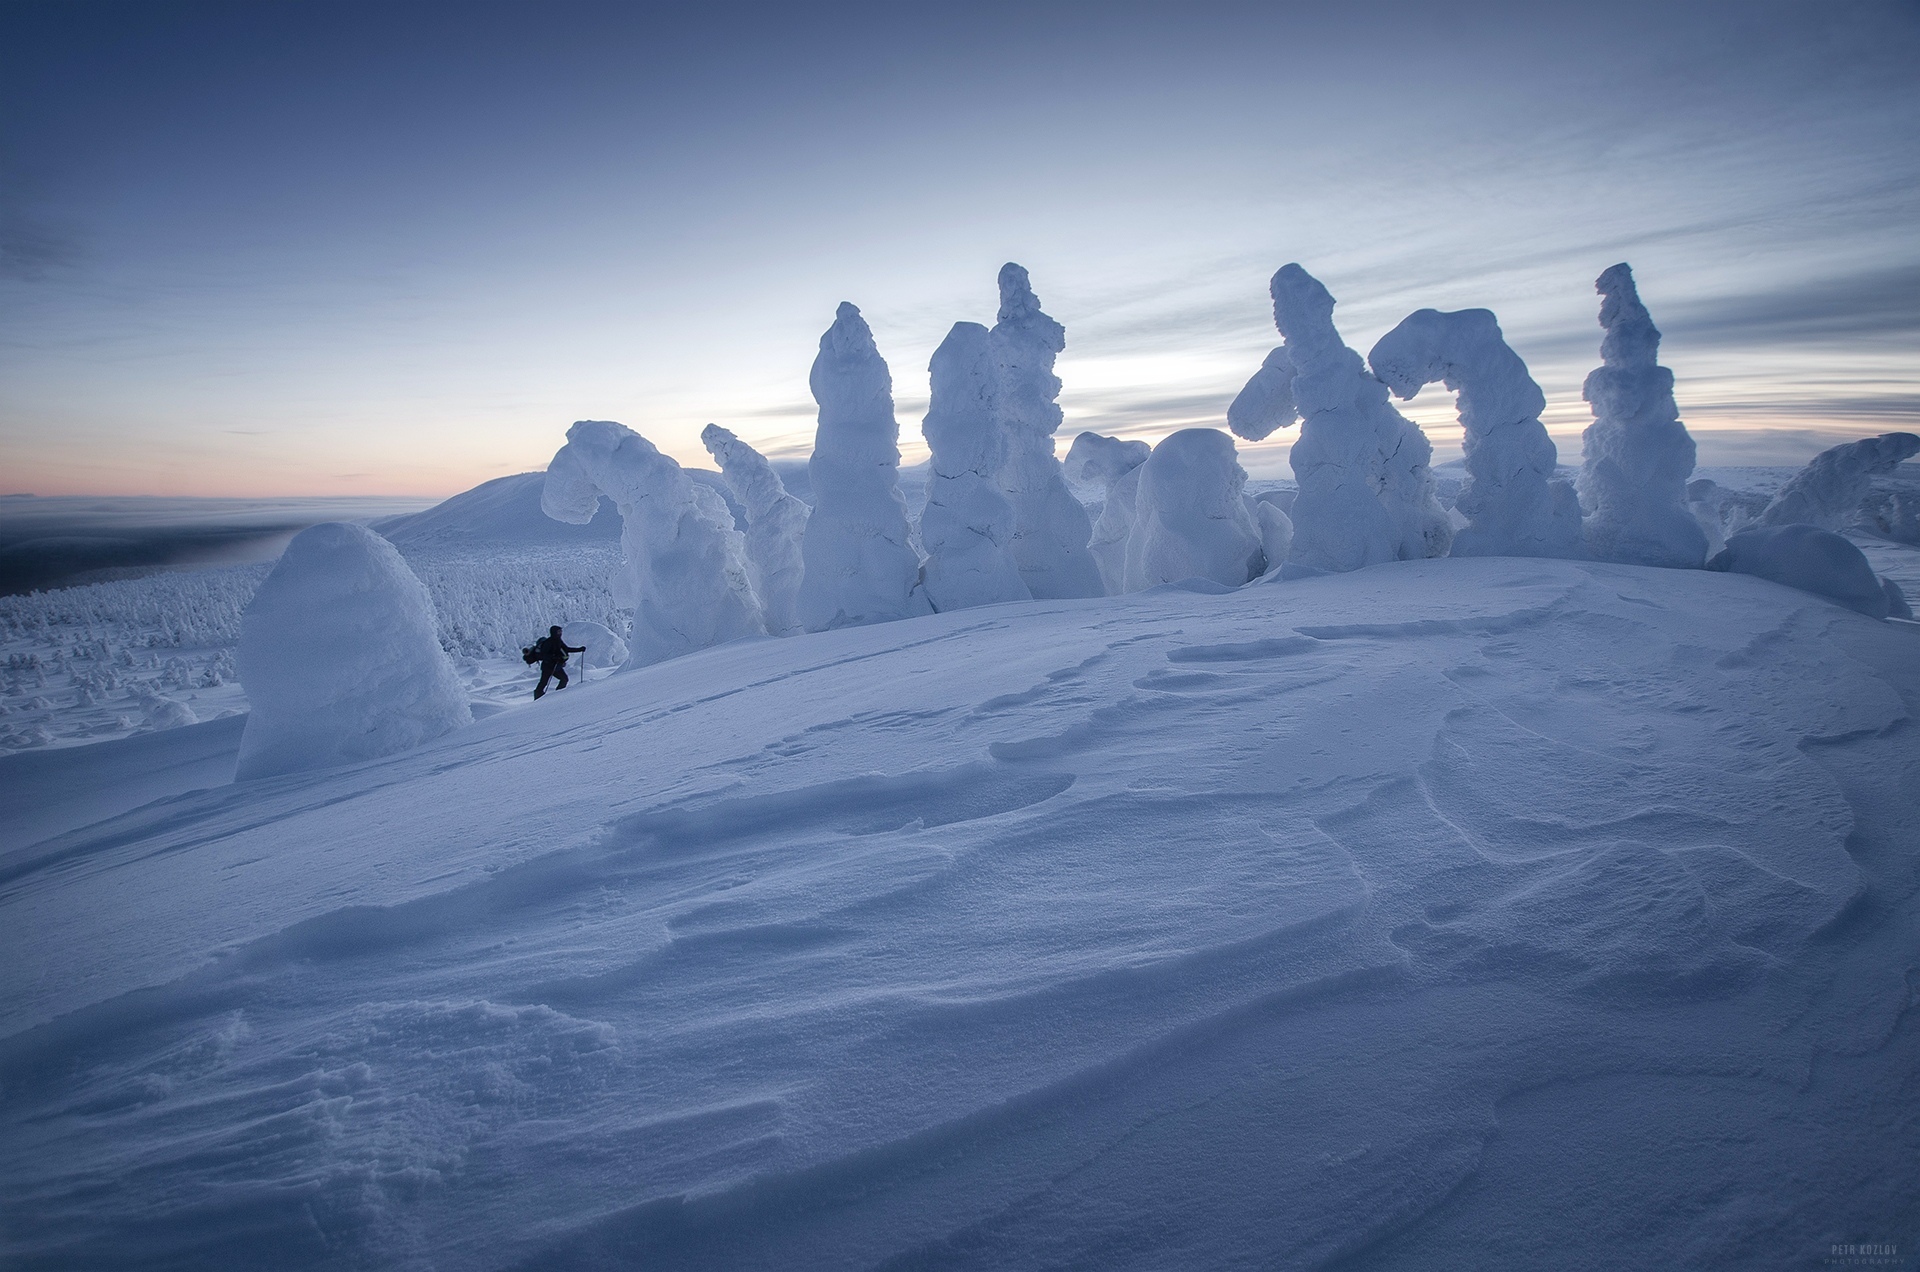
[543,263,1920,665]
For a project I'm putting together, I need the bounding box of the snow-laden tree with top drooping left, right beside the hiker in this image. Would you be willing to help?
[540,419,766,667]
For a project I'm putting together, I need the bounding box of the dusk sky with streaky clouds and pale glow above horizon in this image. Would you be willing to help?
[0,0,1920,496]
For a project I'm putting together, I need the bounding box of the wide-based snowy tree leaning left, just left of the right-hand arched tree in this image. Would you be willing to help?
[1269,265,1453,575]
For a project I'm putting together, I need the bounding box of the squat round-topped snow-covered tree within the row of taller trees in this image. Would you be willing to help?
[1127,428,1267,592]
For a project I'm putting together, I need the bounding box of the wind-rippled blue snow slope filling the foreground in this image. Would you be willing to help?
[0,557,1920,1268]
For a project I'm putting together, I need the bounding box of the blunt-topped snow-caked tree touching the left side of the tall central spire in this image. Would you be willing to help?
[920,323,1036,611]
